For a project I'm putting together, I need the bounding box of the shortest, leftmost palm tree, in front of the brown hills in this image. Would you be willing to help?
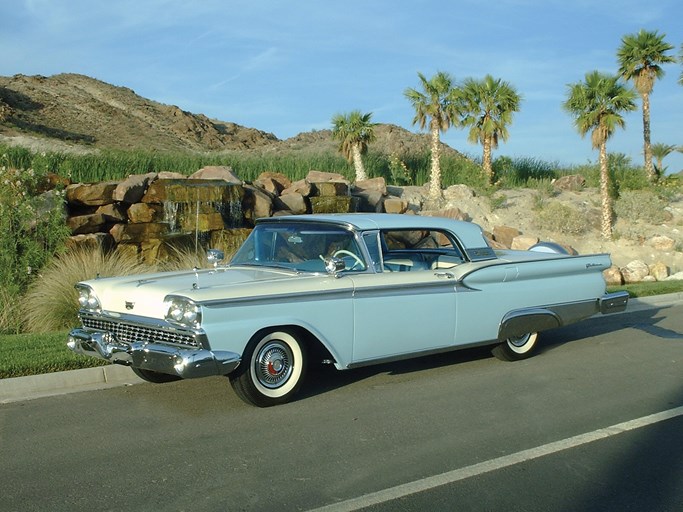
[332,110,375,182]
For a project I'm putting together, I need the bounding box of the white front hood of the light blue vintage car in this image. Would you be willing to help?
[84,267,331,318]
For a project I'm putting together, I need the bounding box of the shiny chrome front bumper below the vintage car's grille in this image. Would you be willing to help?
[67,328,241,379]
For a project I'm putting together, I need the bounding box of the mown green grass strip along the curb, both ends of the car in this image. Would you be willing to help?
[0,281,683,379]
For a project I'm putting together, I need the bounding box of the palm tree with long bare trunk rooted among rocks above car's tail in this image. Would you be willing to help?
[562,71,637,240]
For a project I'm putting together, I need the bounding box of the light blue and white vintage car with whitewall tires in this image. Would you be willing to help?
[68,214,628,406]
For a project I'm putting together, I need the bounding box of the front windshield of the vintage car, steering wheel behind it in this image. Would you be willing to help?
[230,222,367,272]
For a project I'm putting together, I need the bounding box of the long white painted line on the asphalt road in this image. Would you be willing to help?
[311,407,683,512]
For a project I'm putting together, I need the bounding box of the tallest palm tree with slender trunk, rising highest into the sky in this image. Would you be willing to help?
[617,29,676,181]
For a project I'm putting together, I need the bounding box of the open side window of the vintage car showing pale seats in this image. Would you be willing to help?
[380,229,464,272]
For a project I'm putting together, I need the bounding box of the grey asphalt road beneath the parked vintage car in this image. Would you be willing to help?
[0,306,683,512]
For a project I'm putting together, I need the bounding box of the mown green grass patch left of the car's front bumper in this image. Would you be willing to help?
[0,331,108,379]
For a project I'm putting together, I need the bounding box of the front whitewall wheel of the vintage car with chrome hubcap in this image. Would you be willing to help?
[229,330,306,407]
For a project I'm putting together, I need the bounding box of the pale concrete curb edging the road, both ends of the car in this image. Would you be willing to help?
[0,293,683,404]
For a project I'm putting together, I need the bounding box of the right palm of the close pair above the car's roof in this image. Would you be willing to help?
[457,75,522,185]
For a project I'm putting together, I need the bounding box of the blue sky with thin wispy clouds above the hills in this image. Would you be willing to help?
[0,0,683,172]
